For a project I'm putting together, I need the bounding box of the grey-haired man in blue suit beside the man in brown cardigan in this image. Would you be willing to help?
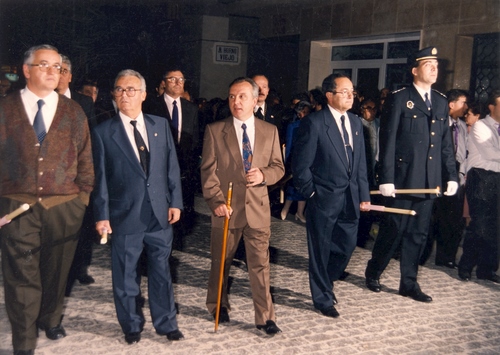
[92,70,183,344]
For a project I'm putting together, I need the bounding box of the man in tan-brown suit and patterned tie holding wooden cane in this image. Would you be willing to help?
[201,78,285,335]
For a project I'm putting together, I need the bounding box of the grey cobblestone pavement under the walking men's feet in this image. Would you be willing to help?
[0,198,500,355]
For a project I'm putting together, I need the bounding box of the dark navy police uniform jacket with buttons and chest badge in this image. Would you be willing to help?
[380,85,458,198]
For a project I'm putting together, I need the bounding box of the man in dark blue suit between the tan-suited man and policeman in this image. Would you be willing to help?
[292,74,370,317]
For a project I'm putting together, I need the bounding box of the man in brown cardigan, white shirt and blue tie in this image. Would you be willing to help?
[0,45,94,354]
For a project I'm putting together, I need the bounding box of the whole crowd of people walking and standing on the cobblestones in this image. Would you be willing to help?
[0,45,500,354]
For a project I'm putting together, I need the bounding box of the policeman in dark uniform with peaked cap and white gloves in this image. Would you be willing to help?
[365,47,458,302]
